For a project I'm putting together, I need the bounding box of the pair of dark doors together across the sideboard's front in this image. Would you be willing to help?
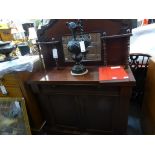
[40,94,120,134]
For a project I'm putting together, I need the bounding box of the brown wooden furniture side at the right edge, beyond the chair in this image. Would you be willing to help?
[142,57,155,134]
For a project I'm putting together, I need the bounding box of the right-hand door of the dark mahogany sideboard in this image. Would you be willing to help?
[80,95,119,133]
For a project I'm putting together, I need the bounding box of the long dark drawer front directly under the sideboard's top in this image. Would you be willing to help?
[38,84,120,96]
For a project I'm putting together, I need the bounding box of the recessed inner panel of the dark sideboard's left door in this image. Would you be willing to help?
[49,94,79,127]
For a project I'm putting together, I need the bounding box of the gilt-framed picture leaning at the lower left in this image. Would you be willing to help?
[0,97,31,135]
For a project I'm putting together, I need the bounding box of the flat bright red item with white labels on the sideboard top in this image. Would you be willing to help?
[99,66,129,81]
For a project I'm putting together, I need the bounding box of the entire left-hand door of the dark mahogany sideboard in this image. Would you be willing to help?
[39,94,80,129]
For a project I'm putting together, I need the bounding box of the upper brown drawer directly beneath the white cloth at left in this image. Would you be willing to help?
[0,74,19,86]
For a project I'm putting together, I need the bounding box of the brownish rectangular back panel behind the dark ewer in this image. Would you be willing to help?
[62,33,101,62]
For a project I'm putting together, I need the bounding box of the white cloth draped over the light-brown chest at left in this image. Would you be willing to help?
[0,56,39,77]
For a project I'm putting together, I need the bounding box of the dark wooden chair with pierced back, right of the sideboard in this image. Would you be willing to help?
[129,53,151,105]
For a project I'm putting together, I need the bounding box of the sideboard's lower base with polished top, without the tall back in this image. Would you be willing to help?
[28,66,135,134]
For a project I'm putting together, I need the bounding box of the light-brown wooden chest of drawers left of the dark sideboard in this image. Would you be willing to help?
[0,58,44,131]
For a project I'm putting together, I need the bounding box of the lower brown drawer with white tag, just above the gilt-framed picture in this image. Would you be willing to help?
[0,87,23,97]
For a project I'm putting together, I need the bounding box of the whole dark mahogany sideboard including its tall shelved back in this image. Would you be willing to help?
[27,19,135,134]
